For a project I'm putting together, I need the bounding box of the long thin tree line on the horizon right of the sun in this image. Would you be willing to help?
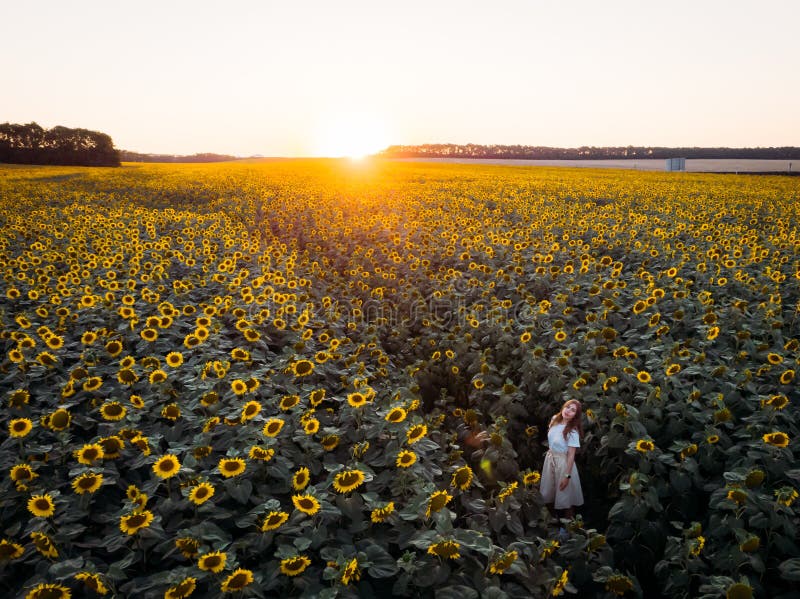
[379,144,800,160]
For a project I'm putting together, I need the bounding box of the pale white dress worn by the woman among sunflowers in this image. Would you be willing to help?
[539,424,583,510]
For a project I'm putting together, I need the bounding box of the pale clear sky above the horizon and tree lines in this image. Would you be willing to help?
[0,0,800,156]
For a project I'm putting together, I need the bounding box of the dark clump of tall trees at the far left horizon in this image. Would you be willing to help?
[0,123,120,166]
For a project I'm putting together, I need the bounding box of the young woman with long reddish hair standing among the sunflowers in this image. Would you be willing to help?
[539,399,583,518]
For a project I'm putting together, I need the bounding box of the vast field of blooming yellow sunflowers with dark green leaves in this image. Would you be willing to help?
[0,160,800,599]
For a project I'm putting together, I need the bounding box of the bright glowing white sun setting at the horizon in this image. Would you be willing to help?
[314,113,389,160]
